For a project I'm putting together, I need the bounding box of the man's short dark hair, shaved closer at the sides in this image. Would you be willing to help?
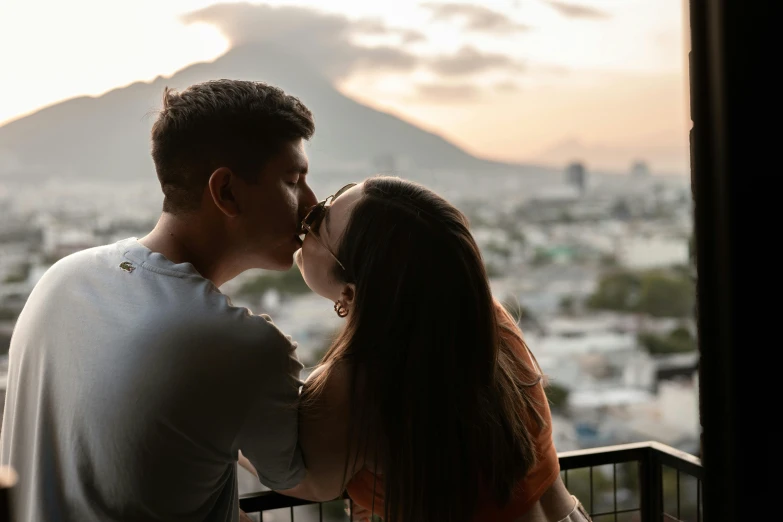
[152,80,315,213]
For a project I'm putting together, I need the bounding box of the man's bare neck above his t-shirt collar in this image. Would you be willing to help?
[139,212,241,287]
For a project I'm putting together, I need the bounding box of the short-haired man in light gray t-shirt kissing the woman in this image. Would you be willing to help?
[0,80,316,522]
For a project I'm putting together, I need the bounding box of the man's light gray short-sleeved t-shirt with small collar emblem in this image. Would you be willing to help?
[0,239,305,522]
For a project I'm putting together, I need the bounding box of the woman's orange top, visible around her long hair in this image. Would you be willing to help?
[347,305,560,522]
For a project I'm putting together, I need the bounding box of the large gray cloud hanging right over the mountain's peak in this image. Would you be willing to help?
[183,3,424,80]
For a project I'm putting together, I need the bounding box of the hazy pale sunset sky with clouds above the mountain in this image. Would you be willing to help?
[0,0,687,173]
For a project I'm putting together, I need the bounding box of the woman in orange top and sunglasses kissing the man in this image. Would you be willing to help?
[284,177,589,522]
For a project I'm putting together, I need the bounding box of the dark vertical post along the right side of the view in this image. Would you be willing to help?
[690,0,783,522]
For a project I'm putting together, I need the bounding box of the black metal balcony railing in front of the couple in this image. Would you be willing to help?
[239,442,704,522]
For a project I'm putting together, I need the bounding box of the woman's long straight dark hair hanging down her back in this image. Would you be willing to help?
[303,177,543,522]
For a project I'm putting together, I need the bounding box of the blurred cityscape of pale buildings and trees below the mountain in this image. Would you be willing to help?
[0,162,700,508]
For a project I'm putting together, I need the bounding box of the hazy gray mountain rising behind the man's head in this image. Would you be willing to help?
[0,45,542,181]
